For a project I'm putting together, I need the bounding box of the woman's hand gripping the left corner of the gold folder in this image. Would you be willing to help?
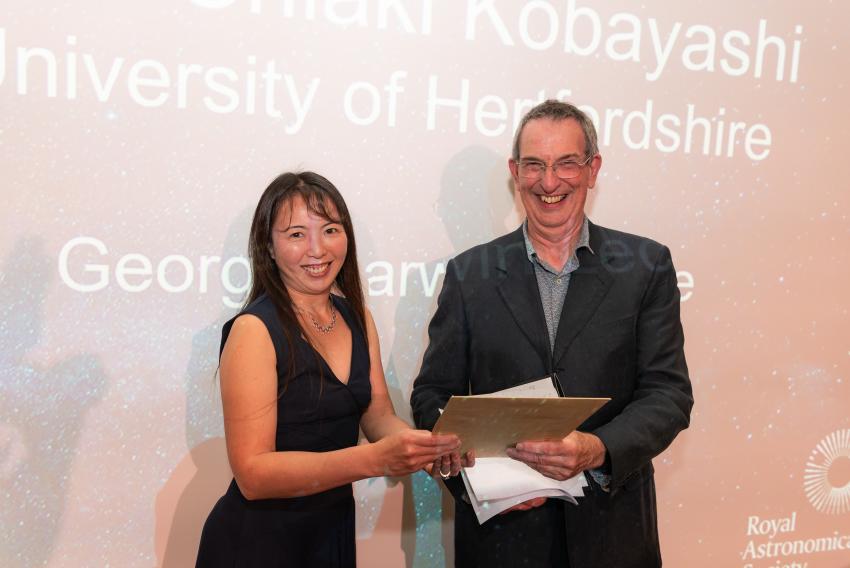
[374,429,460,477]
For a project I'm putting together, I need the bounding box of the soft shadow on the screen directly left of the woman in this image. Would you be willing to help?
[154,209,253,568]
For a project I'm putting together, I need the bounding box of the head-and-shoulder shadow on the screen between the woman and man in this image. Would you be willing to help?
[386,146,522,568]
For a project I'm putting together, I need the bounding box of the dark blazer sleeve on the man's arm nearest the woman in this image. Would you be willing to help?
[410,259,469,499]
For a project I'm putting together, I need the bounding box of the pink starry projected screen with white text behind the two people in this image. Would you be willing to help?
[0,0,850,568]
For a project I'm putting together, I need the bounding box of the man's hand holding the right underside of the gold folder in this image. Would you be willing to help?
[507,431,605,481]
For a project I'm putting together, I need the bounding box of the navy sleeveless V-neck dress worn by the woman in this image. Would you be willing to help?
[196,296,372,568]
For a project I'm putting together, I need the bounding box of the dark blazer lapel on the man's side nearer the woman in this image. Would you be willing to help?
[493,228,551,362]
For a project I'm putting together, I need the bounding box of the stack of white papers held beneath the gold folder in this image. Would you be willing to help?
[461,457,587,524]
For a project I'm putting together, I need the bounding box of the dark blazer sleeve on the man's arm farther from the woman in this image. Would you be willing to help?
[593,247,693,489]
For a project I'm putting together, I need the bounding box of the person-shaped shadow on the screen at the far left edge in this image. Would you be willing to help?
[0,237,106,566]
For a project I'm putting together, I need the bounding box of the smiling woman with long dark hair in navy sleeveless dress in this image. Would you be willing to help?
[197,172,460,568]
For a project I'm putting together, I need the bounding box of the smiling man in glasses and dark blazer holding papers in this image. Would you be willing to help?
[411,101,693,568]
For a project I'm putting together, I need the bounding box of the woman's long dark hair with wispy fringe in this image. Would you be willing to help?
[245,172,369,388]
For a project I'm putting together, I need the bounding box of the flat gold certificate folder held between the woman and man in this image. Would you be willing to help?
[433,396,611,458]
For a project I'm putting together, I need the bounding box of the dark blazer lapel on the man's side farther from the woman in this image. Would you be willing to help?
[554,225,613,363]
